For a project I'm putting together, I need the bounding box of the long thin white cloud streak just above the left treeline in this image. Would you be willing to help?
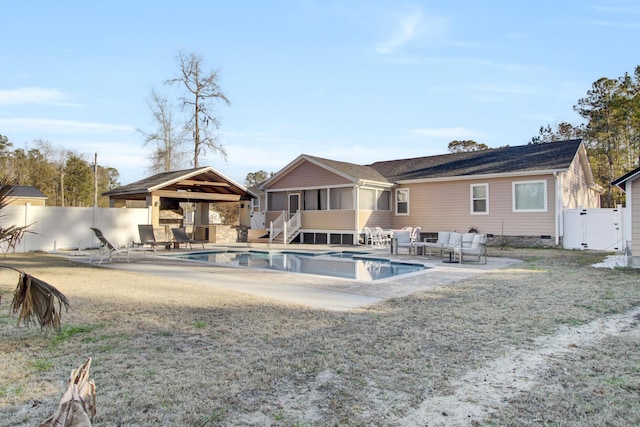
[0,117,135,134]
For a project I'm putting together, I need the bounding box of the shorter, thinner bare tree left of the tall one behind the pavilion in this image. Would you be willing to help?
[138,90,185,172]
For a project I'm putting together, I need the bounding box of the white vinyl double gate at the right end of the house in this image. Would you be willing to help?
[562,208,625,252]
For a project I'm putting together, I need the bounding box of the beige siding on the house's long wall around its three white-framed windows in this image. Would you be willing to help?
[391,175,555,236]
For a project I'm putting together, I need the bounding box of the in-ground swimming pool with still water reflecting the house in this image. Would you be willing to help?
[172,250,427,280]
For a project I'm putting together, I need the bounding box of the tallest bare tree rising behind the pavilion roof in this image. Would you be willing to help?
[166,51,230,167]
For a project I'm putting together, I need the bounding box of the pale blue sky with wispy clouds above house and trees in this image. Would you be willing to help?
[0,0,640,185]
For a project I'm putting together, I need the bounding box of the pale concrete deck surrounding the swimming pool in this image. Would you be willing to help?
[69,243,520,311]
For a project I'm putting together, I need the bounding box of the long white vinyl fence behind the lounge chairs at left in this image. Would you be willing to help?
[0,204,151,252]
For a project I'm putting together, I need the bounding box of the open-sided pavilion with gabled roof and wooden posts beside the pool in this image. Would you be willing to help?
[102,166,257,241]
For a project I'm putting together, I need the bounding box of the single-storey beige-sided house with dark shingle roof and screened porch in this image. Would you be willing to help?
[260,139,600,246]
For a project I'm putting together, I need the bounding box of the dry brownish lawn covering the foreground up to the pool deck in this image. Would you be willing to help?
[0,249,640,426]
